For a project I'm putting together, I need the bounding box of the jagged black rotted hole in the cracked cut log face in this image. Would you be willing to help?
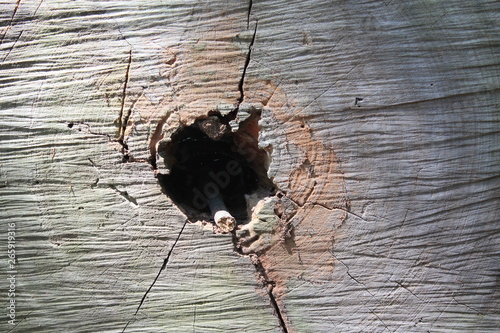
[158,126,259,220]
